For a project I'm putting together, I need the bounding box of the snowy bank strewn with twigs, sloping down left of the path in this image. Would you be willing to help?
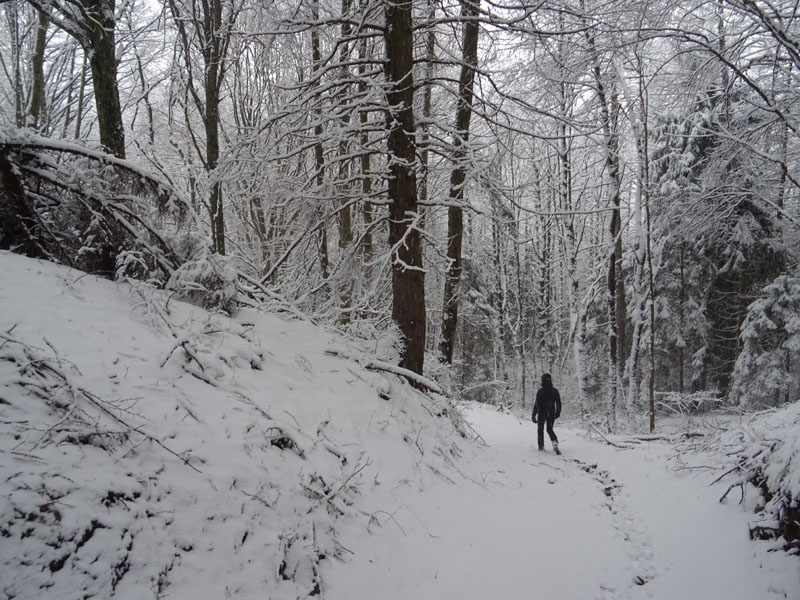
[0,253,461,599]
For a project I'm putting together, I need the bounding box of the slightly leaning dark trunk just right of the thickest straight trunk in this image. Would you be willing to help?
[439,0,480,364]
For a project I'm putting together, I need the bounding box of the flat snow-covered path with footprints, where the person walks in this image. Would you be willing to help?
[324,407,800,600]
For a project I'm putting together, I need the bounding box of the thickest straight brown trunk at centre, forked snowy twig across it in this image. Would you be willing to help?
[385,1,426,374]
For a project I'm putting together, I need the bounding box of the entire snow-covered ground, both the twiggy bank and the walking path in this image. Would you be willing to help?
[0,252,800,600]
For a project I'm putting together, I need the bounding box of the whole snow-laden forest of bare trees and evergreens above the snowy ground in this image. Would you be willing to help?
[0,0,800,432]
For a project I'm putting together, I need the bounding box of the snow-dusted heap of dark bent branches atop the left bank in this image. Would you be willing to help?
[0,129,237,313]
